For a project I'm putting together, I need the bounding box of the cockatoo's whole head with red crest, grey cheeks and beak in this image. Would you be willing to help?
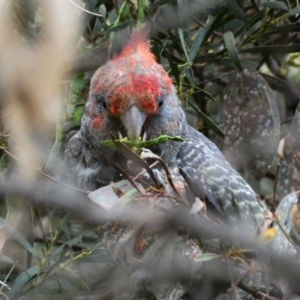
[86,26,183,156]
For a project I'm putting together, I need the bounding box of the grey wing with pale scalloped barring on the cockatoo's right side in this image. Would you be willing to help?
[177,127,264,227]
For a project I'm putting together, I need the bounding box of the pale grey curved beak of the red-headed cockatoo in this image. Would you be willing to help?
[120,105,147,142]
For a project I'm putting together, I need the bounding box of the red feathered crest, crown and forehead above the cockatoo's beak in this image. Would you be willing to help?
[91,25,172,116]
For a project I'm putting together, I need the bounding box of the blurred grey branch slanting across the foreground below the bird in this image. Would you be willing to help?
[0,181,300,299]
